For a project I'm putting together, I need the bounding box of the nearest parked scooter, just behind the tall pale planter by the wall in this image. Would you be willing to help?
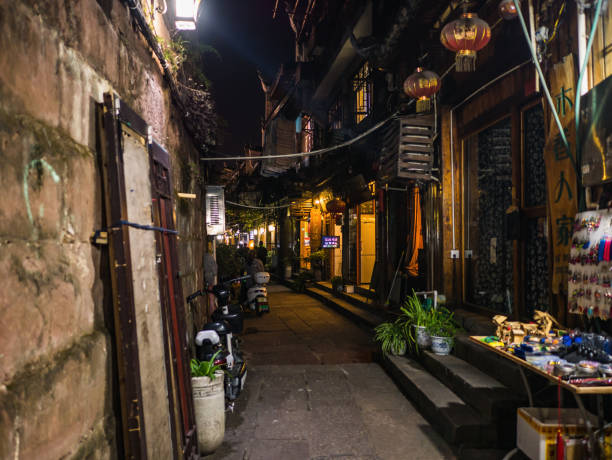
[187,278,247,410]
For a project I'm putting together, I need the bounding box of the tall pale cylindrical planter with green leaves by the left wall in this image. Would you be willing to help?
[190,351,225,454]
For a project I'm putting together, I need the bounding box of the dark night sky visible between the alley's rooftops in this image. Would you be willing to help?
[194,0,294,154]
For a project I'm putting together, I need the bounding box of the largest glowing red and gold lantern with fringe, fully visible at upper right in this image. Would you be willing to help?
[440,13,491,72]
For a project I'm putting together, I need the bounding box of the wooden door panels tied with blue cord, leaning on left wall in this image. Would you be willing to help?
[101,94,198,458]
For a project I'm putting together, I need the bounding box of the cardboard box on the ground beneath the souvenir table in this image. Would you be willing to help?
[516,407,597,460]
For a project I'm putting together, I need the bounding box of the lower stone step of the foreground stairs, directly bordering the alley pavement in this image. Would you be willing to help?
[382,355,497,447]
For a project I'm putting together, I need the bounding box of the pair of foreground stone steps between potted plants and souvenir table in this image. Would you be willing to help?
[382,338,525,460]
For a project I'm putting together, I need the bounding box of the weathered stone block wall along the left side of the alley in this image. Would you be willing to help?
[0,0,203,459]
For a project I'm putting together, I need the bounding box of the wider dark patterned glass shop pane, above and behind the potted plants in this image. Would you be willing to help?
[463,118,514,313]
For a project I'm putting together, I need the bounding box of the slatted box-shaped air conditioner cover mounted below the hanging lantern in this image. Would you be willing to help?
[379,115,435,183]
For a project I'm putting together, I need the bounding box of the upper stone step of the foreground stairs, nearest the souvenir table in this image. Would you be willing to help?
[421,351,525,448]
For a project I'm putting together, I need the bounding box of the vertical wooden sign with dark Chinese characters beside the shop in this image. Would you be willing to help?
[544,55,578,294]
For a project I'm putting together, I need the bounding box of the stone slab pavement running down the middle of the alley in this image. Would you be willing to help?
[205,286,454,460]
